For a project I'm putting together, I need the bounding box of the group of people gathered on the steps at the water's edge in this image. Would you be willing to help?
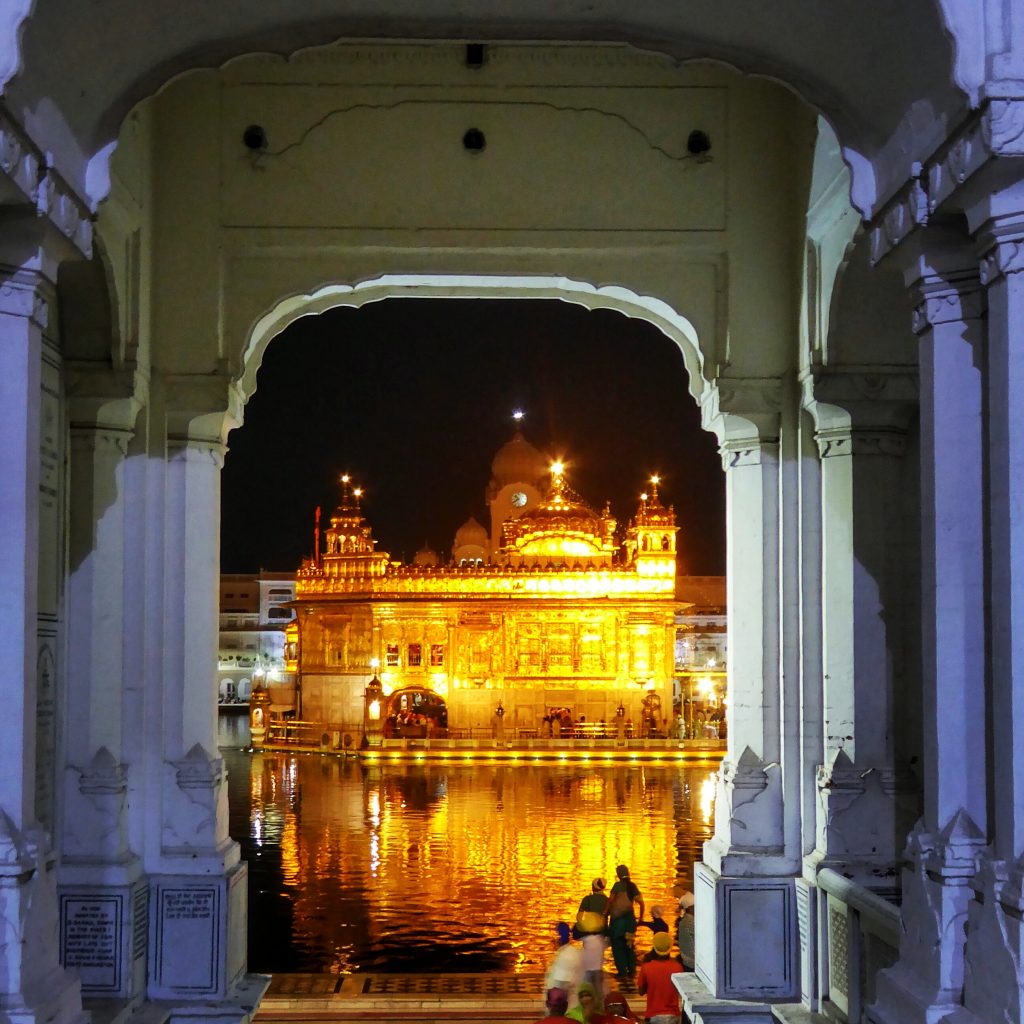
[538,864,694,1024]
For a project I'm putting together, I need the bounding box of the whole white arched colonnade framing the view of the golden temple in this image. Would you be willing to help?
[0,0,1024,1024]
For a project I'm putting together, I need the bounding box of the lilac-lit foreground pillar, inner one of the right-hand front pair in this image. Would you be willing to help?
[868,232,988,1024]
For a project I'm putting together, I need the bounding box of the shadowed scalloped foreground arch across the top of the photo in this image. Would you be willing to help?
[0,0,966,214]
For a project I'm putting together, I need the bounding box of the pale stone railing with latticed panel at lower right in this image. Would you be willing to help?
[817,867,901,1024]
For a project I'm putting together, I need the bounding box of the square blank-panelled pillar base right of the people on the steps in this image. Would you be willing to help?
[693,863,800,999]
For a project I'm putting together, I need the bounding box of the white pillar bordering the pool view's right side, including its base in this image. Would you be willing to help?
[694,380,800,998]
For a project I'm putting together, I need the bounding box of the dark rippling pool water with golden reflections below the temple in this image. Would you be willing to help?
[221,716,713,973]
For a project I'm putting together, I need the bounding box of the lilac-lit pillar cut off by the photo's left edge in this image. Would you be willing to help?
[0,266,85,1024]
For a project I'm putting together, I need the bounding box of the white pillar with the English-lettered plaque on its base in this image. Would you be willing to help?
[58,397,147,1001]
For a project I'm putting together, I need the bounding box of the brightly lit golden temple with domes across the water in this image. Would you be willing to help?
[286,430,677,737]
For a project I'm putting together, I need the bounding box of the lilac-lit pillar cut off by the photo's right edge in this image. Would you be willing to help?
[964,211,1024,1021]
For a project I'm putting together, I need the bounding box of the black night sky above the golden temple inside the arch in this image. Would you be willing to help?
[221,298,725,574]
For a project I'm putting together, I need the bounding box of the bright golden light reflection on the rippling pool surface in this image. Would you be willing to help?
[233,751,715,970]
